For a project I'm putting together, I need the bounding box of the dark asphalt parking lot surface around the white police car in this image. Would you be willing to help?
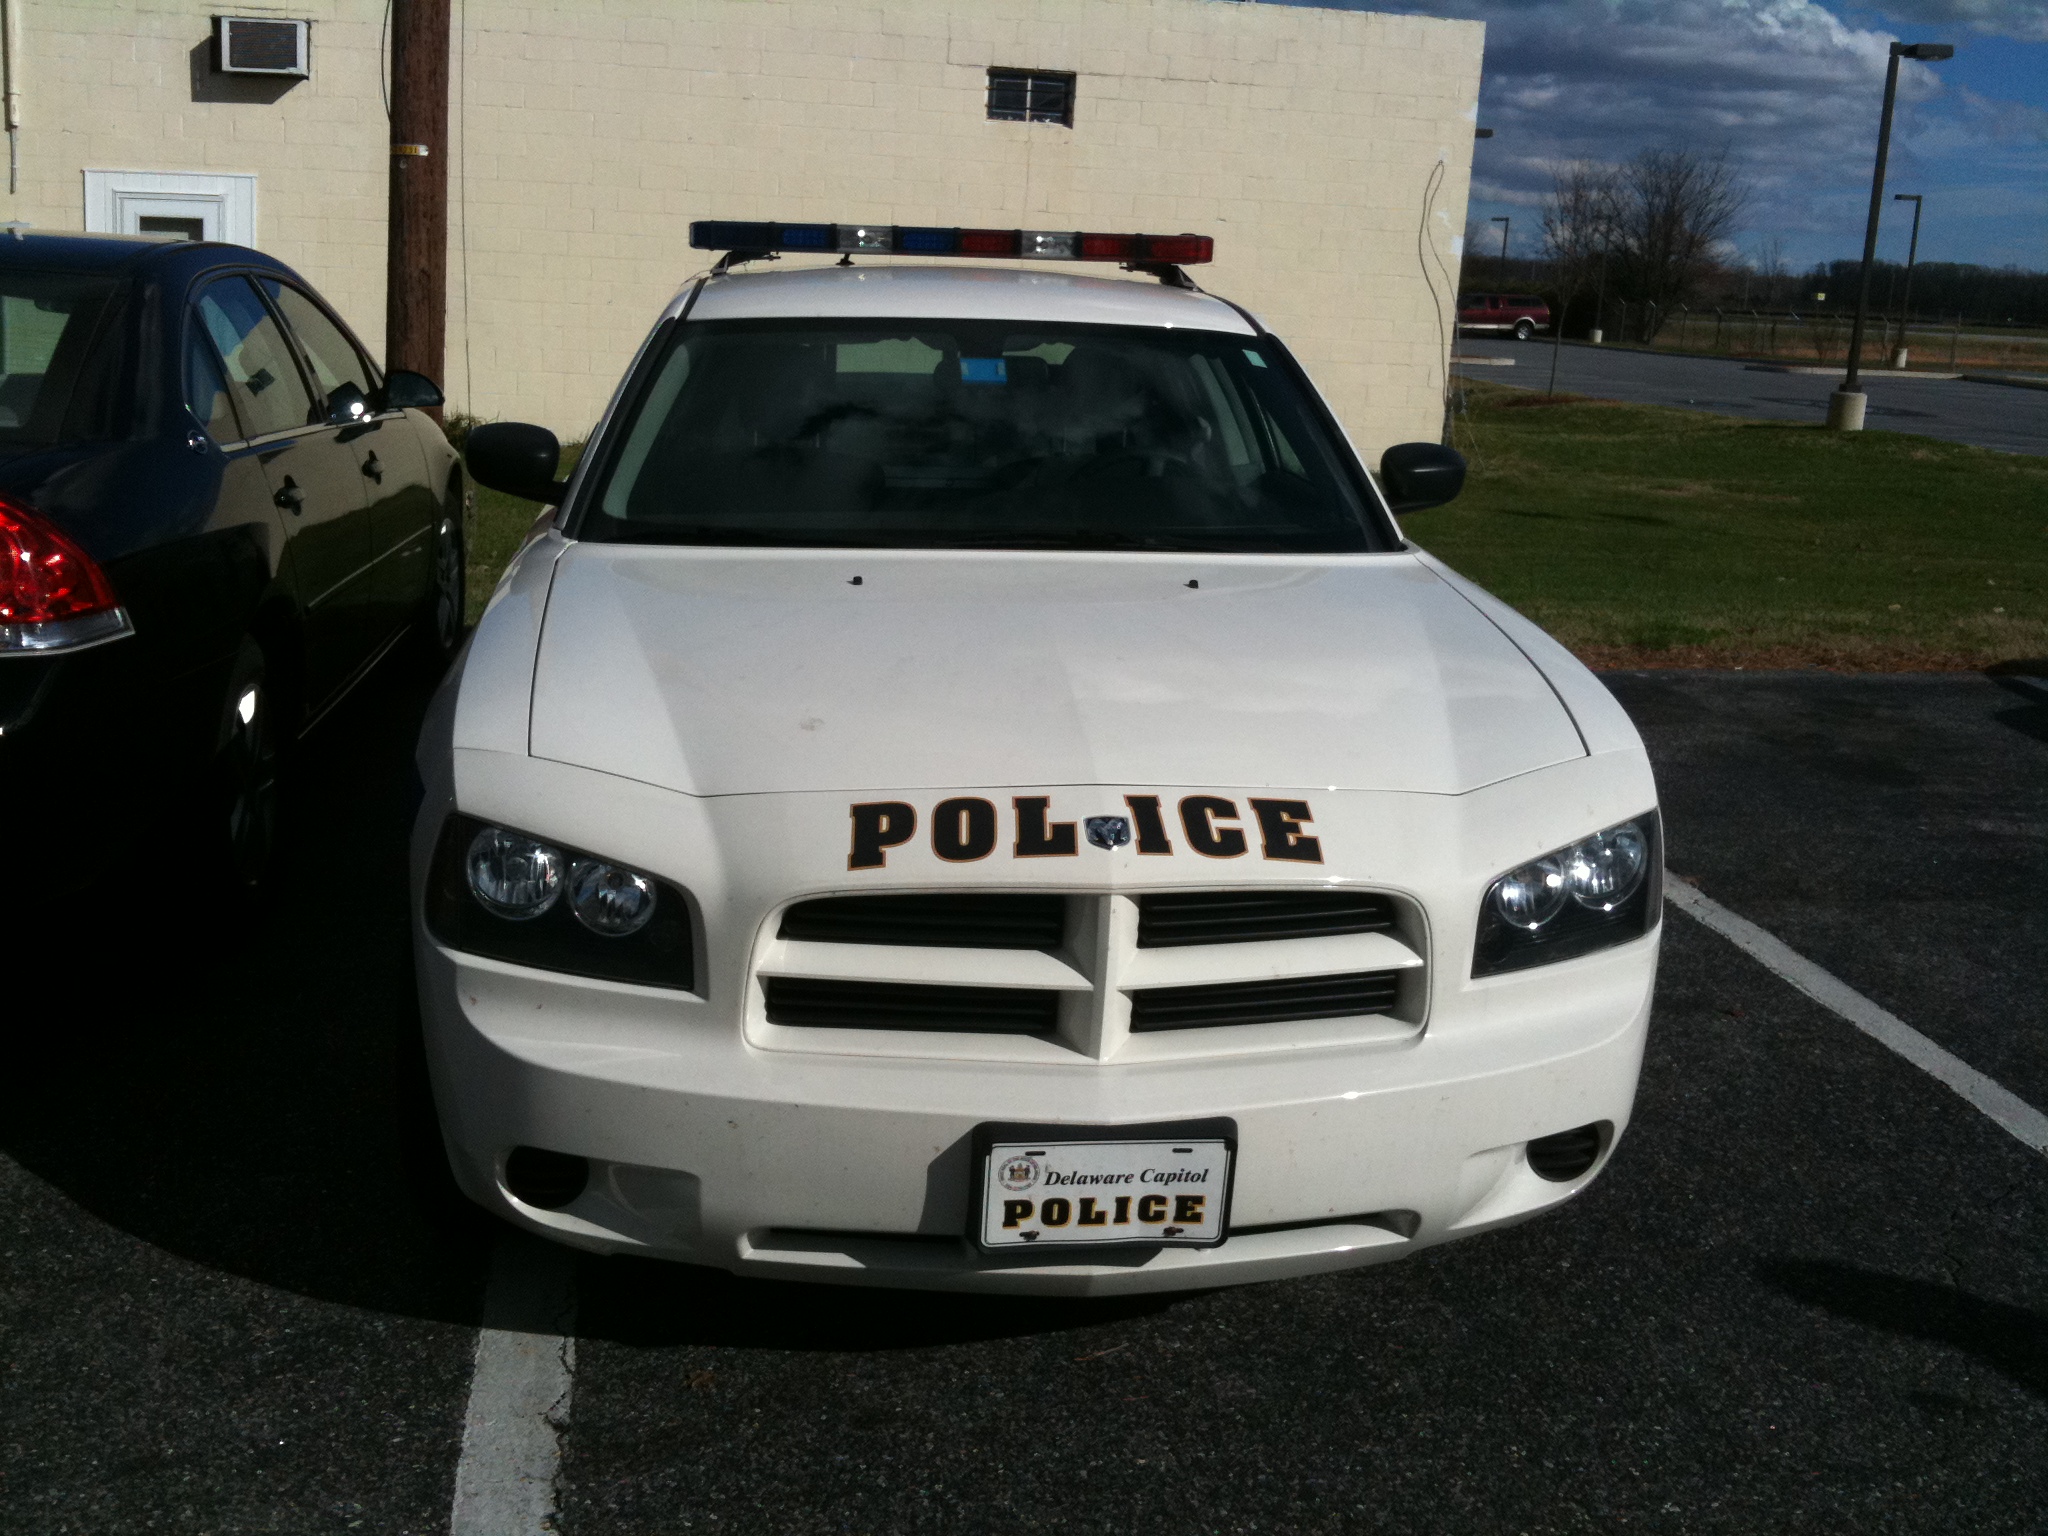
[0,674,2048,1536]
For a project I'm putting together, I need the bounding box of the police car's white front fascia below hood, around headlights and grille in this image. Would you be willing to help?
[414,729,1661,1296]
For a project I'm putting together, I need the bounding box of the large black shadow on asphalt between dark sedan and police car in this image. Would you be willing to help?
[0,664,483,1321]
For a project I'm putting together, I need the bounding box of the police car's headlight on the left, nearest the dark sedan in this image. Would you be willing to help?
[426,815,694,991]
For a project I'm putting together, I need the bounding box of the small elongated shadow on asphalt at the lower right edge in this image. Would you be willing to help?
[1757,1260,2048,1399]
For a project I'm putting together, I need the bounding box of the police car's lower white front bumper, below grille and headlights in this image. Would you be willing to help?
[420,934,1657,1296]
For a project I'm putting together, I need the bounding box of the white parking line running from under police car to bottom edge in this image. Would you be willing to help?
[449,1233,575,1536]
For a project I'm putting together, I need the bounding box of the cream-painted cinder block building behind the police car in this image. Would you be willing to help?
[6,0,1483,455]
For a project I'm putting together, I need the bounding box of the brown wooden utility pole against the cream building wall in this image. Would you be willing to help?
[385,0,449,418]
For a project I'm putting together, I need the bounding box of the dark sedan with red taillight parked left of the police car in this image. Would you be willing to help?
[0,233,463,889]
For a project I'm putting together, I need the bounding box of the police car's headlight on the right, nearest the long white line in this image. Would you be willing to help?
[1473,811,1663,977]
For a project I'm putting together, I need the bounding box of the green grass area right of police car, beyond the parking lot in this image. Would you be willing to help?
[1405,385,2048,670]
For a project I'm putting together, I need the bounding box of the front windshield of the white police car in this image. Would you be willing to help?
[575,319,1391,553]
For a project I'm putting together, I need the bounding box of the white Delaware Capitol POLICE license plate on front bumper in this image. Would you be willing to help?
[975,1120,1237,1249]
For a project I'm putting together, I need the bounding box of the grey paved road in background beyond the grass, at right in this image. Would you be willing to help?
[1458,336,2048,453]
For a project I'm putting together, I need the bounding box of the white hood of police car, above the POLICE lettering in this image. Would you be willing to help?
[530,543,1585,795]
